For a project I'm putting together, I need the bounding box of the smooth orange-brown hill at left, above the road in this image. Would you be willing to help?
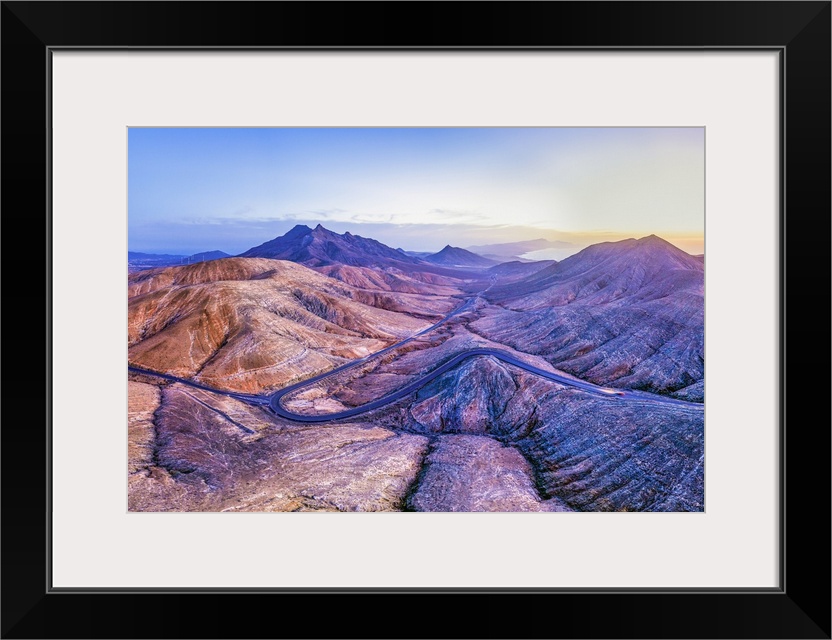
[128,258,436,392]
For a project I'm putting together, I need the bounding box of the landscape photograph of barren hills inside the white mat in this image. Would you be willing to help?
[126,127,706,517]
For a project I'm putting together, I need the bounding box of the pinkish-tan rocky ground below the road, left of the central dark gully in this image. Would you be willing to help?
[128,382,428,511]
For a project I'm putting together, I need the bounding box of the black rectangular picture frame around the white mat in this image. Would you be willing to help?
[0,1,832,638]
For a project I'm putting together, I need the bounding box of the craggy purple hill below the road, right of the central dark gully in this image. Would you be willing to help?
[406,357,705,511]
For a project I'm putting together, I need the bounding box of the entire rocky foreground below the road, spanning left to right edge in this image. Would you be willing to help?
[129,350,704,511]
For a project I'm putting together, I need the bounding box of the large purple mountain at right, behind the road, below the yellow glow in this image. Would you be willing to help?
[472,236,704,401]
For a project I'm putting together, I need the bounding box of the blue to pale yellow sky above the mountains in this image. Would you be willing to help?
[128,127,705,259]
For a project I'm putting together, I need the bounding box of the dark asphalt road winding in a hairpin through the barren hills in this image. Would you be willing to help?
[127,296,704,423]
